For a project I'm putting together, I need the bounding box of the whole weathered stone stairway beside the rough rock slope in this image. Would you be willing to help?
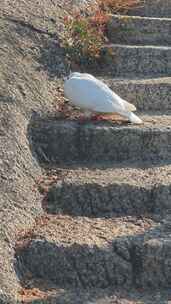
[16,1,171,304]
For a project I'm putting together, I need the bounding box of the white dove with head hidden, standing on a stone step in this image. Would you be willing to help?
[64,72,142,124]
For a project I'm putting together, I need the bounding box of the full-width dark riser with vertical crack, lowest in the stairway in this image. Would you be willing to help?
[16,236,171,289]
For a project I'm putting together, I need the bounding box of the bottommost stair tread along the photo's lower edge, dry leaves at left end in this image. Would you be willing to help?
[17,279,171,304]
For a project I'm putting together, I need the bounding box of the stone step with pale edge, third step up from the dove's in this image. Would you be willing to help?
[108,15,171,46]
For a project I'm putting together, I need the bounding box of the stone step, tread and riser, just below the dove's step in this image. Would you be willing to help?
[43,164,171,217]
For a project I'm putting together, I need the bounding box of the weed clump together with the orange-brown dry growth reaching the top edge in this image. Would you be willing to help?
[61,0,143,66]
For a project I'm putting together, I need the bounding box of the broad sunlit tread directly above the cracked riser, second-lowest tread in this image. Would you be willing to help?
[19,215,157,248]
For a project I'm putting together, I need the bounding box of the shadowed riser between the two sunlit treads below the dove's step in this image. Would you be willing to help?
[44,181,171,217]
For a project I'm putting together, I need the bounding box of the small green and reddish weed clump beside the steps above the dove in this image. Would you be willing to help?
[62,12,109,65]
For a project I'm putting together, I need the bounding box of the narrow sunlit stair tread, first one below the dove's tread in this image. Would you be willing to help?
[48,161,171,188]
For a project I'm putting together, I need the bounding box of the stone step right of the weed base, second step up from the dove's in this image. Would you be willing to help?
[102,44,171,78]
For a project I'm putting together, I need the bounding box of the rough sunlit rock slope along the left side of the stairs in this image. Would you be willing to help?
[0,0,67,304]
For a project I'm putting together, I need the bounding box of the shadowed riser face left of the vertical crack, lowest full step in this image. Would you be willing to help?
[16,240,132,289]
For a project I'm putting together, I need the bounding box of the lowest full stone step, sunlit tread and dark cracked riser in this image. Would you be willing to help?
[15,215,171,290]
